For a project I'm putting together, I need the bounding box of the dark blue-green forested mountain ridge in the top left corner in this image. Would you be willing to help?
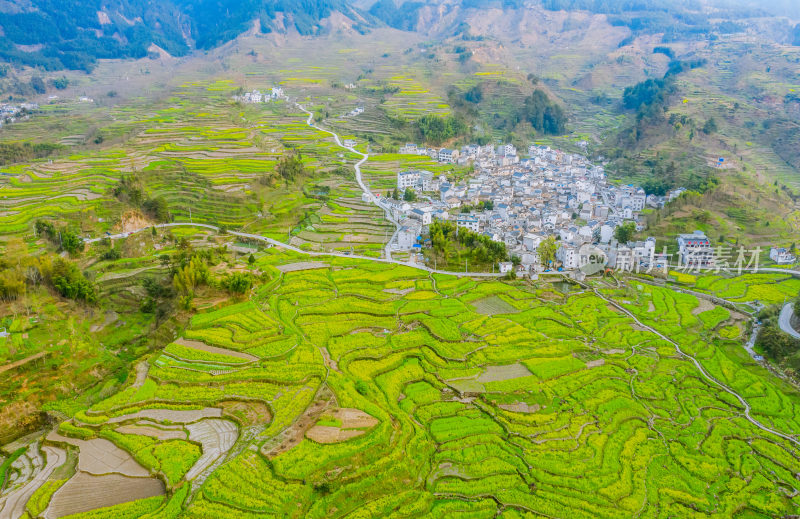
[0,0,372,72]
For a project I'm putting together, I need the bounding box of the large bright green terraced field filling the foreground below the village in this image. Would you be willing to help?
[10,249,800,519]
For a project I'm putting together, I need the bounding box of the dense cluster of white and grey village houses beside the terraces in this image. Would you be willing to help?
[379,144,795,276]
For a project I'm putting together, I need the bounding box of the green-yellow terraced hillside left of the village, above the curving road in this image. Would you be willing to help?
[0,80,393,254]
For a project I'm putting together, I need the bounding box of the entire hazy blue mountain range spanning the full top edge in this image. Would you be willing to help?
[0,0,800,72]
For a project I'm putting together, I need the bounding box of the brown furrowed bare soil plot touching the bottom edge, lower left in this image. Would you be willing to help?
[44,472,164,519]
